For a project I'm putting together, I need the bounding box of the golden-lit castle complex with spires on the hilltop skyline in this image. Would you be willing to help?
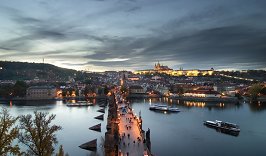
[133,62,214,76]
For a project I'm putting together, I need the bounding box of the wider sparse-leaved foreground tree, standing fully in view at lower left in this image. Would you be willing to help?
[18,111,62,156]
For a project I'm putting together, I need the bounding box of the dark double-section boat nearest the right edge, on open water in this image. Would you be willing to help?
[204,120,240,132]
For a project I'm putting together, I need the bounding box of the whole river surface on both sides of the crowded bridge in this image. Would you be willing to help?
[1,98,266,156]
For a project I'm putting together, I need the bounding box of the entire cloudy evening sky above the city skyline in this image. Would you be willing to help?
[0,0,266,71]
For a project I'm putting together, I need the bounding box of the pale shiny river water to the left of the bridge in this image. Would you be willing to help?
[0,101,107,156]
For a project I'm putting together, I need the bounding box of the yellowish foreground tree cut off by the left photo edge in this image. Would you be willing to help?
[0,108,21,156]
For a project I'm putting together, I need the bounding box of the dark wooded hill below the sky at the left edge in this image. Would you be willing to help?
[0,61,82,81]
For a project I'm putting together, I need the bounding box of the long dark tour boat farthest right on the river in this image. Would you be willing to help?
[203,120,240,136]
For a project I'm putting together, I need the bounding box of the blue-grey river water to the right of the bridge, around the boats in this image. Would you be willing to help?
[127,98,266,156]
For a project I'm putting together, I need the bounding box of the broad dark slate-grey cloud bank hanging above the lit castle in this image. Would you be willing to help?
[84,26,266,68]
